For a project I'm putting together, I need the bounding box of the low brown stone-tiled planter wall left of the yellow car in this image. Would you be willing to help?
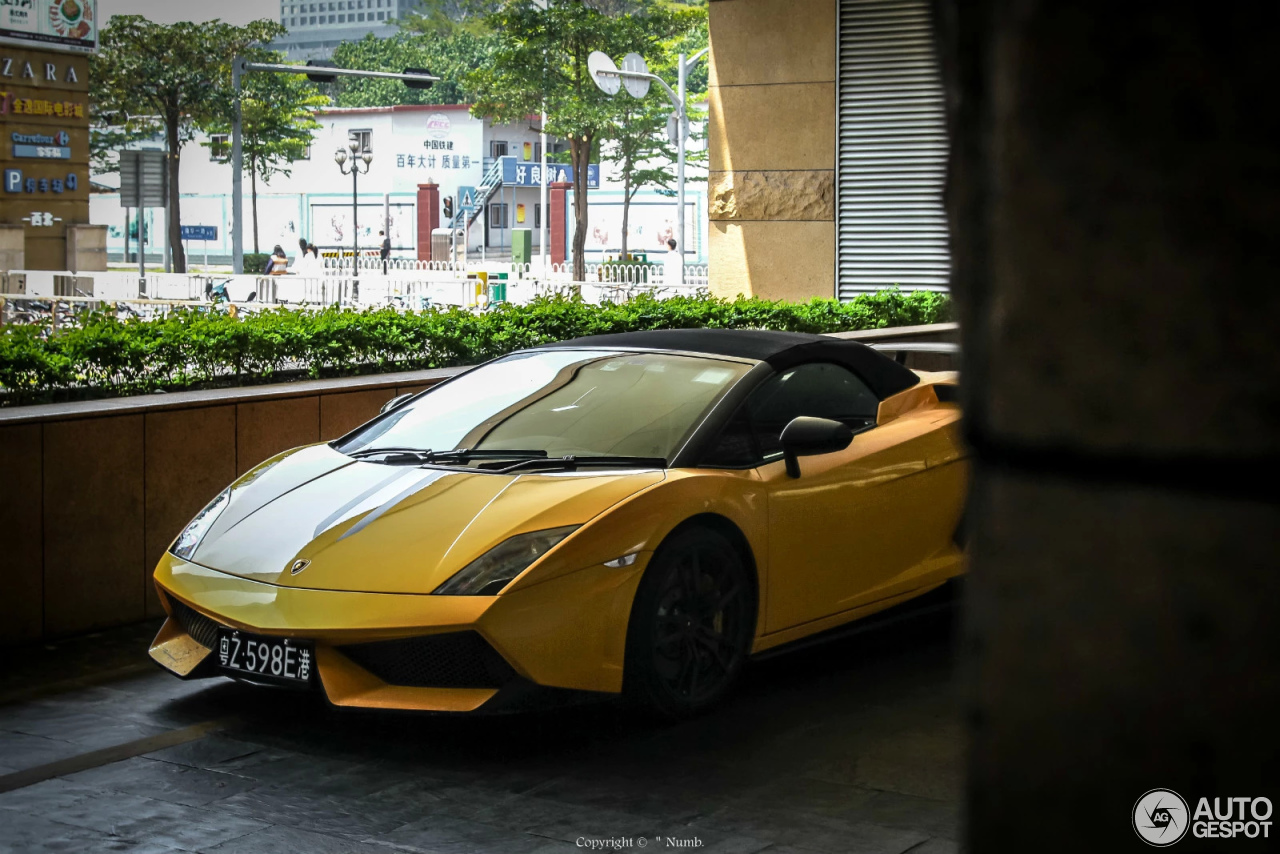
[0,367,463,644]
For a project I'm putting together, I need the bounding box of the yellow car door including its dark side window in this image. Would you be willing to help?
[701,362,934,632]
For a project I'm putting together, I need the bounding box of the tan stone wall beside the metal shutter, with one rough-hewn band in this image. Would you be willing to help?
[709,0,836,300]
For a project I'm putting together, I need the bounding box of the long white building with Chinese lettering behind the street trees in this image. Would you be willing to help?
[90,105,708,264]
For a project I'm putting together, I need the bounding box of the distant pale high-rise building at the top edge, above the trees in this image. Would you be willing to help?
[271,0,419,59]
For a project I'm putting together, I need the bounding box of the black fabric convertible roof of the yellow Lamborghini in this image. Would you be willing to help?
[543,329,920,399]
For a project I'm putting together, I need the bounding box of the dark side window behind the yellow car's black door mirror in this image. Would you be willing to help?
[704,362,879,469]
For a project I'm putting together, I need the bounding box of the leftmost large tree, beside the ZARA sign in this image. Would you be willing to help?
[90,15,285,273]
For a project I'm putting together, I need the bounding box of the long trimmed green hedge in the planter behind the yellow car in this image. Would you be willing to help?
[0,289,950,405]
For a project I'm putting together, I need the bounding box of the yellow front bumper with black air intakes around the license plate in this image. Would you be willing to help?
[150,554,648,712]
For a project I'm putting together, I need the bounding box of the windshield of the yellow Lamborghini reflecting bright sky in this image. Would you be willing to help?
[335,350,751,461]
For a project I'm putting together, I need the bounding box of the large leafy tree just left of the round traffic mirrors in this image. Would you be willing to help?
[467,0,671,282]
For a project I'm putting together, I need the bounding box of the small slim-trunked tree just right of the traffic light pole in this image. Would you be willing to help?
[204,66,329,254]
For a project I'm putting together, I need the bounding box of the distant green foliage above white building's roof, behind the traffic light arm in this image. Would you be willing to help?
[333,32,493,106]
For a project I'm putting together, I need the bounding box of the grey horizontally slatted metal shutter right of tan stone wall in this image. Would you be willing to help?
[836,0,951,300]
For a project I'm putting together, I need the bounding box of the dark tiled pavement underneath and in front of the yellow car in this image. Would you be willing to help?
[0,615,961,854]
